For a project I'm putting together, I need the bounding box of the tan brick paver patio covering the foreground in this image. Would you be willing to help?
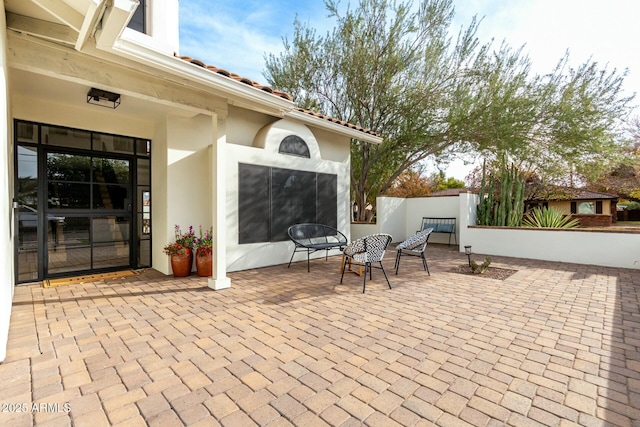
[0,245,640,427]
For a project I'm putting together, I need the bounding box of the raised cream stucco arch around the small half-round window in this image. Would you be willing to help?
[253,119,321,160]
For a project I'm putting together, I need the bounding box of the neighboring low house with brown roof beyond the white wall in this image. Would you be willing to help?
[525,188,618,226]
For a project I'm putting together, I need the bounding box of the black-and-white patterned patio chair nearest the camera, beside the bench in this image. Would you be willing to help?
[340,233,392,293]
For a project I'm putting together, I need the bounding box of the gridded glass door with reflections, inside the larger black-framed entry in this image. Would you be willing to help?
[45,151,132,276]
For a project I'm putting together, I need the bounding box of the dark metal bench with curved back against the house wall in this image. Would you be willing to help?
[287,223,347,271]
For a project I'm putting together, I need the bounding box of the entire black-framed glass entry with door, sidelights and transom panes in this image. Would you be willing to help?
[14,121,151,282]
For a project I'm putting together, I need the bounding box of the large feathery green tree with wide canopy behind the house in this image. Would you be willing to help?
[265,0,632,220]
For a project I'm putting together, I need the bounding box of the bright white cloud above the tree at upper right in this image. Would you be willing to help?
[454,0,640,103]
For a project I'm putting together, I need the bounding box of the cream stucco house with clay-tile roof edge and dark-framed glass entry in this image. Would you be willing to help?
[0,0,381,361]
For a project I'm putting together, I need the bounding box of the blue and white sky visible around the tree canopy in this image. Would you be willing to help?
[179,0,640,179]
